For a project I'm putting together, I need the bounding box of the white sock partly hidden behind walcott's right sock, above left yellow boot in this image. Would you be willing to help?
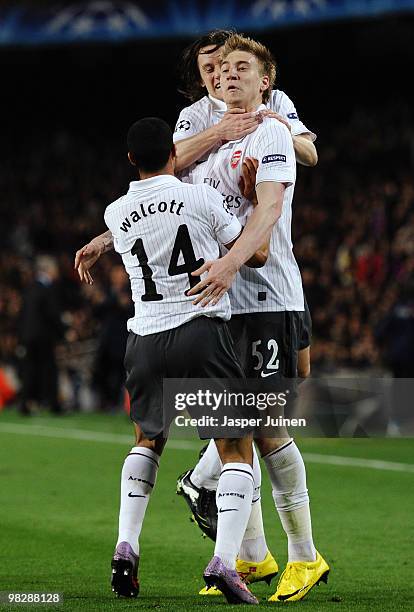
[239,445,268,563]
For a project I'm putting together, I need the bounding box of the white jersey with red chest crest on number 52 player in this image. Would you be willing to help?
[183,106,304,314]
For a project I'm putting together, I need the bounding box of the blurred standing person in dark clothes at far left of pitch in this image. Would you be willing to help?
[19,256,63,414]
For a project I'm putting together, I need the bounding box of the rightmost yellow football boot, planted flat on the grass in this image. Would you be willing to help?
[269,551,329,601]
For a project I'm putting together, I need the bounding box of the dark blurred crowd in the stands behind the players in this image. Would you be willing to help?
[0,2,414,412]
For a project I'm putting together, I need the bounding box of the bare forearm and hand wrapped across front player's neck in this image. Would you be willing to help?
[175,108,263,172]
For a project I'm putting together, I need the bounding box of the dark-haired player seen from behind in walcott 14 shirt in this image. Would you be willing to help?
[104,118,267,604]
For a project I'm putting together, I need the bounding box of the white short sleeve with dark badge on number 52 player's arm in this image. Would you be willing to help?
[251,119,296,185]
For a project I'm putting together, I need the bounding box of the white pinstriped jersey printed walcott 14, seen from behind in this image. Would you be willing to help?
[105,175,241,336]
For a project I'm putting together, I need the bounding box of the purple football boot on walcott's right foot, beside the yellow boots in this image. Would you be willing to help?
[204,557,259,604]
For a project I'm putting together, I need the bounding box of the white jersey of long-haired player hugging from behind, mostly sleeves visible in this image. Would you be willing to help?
[174,89,316,142]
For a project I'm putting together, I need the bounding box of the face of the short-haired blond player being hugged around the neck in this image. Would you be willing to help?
[220,51,269,111]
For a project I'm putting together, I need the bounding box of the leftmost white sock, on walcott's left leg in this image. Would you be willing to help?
[116,446,160,555]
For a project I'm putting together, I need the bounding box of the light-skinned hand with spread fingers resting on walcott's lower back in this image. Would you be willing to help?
[187,253,239,308]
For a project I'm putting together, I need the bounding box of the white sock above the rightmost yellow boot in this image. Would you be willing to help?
[263,440,316,562]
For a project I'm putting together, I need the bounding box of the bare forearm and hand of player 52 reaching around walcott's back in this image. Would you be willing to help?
[188,181,285,306]
